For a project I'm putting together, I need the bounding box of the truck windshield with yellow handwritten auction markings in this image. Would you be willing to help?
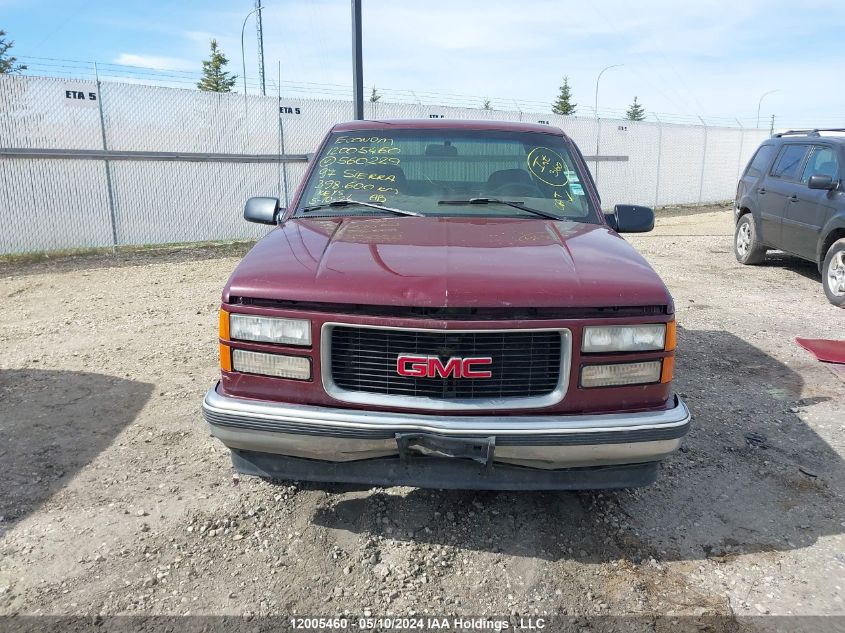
[296,130,600,224]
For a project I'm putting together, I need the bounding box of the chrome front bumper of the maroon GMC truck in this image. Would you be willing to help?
[202,387,690,469]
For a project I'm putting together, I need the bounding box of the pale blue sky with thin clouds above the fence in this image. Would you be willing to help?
[0,0,845,128]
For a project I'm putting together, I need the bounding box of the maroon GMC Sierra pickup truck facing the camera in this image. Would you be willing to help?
[203,120,690,490]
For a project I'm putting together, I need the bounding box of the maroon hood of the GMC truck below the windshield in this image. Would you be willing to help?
[223,217,671,308]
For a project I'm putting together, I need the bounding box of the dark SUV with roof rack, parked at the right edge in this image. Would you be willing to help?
[734,129,845,307]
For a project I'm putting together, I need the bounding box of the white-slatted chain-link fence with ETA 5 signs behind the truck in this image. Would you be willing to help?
[0,75,767,254]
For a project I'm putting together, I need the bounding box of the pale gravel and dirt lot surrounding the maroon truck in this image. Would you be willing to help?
[0,207,845,619]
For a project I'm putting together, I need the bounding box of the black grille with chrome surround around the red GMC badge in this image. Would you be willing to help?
[322,323,571,409]
